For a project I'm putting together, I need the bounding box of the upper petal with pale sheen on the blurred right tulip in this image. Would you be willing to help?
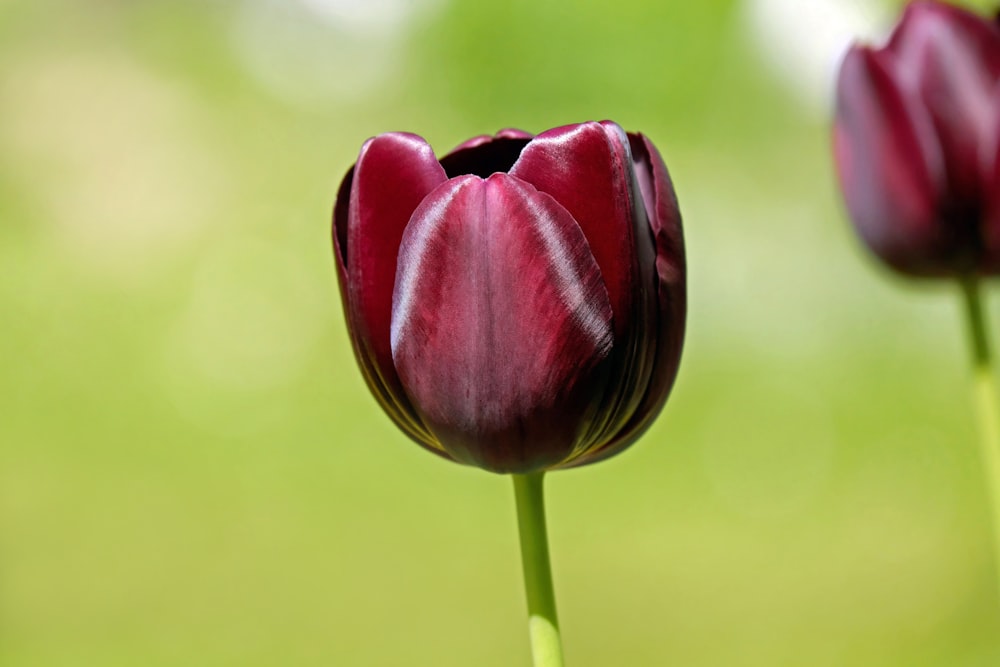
[888,2,1000,198]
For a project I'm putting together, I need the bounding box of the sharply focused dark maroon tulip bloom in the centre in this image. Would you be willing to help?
[333,121,686,473]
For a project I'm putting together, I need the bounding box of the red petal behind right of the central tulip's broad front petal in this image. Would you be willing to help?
[510,122,636,341]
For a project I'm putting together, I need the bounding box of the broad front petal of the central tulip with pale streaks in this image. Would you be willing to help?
[392,174,612,472]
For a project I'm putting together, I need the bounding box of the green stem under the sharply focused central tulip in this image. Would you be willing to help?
[513,472,563,667]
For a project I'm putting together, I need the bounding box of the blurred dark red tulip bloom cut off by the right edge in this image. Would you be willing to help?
[834,1,1000,276]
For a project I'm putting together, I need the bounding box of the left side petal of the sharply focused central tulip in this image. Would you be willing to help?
[333,133,445,450]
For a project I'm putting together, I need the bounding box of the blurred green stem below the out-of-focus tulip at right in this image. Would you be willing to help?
[962,276,1000,604]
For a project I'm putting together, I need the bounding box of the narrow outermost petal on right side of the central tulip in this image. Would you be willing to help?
[571,134,687,466]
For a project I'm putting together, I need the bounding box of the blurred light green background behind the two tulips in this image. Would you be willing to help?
[0,0,1000,667]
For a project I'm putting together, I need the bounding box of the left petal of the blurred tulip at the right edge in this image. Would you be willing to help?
[834,47,961,275]
